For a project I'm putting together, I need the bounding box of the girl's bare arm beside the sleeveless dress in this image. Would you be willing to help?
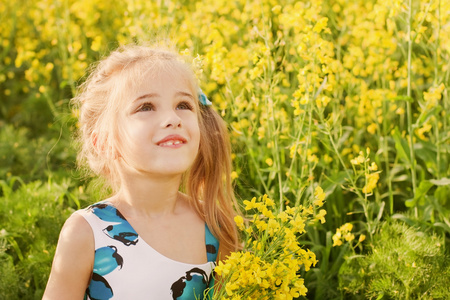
[43,214,95,300]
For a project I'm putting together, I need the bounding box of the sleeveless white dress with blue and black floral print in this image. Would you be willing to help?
[76,202,219,300]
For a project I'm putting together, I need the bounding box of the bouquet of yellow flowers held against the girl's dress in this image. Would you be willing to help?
[207,191,326,300]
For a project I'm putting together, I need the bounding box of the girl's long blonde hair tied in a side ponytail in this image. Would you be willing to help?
[72,45,238,259]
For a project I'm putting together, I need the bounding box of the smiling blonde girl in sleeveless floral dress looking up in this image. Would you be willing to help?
[44,46,238,300]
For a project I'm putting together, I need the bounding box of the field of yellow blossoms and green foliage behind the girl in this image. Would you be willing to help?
[0,0,450,299]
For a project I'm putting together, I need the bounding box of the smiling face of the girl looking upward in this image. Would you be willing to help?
[117,67,200,176]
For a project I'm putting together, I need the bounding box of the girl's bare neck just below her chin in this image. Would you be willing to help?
[111,176,181,219]
